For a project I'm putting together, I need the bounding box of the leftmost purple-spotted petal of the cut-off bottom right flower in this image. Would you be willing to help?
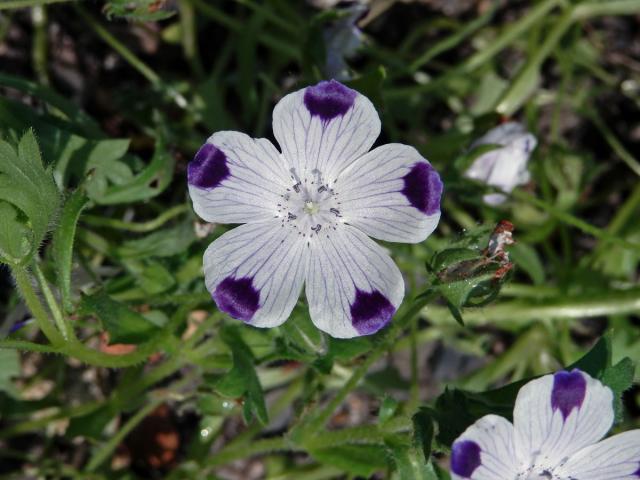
[451,415,518,480]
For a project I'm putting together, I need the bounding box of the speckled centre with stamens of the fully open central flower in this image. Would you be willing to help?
[276,168,342,245]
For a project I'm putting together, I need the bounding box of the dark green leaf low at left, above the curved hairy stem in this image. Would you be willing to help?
[80,291,158,344]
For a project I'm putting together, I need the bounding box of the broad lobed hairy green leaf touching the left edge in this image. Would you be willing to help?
[0,130,60,264]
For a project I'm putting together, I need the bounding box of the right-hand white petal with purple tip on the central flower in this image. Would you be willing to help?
[335,143,442,243]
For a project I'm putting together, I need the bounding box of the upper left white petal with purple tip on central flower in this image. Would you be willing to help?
[188,132,291,223]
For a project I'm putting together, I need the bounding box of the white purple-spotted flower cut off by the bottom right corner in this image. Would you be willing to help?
[451,369,640,480]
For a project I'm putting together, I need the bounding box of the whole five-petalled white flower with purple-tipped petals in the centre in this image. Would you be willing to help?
[188,80,442,338]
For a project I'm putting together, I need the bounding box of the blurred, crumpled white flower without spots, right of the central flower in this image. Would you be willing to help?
[464,122,538,205]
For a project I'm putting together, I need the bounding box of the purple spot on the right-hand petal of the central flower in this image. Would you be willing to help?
[401,162,442,215]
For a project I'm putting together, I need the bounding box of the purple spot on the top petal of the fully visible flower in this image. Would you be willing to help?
[304,80,358,122]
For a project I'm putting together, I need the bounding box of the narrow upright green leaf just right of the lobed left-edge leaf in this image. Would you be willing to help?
[52,189,88,312]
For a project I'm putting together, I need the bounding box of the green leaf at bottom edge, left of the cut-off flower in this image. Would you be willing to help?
[309,445,389,478]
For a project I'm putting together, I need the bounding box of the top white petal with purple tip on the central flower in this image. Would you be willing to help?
[273,80,380,181]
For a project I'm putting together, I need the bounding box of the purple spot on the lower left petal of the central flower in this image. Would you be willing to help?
[212,277,260,322]
